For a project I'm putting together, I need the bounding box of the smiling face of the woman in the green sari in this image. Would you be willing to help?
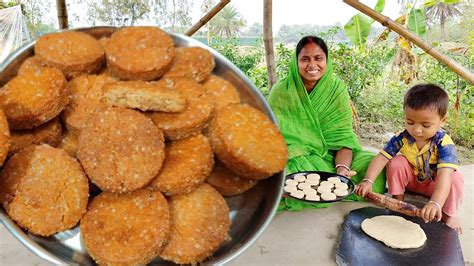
[298,43,326,87]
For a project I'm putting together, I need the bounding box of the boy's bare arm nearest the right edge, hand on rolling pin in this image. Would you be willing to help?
[421,168,454,221]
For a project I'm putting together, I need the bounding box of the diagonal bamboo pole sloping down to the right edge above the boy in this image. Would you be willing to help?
[343,0,474,84]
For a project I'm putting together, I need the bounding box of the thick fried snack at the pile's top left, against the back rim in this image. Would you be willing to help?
[35,31,105,79]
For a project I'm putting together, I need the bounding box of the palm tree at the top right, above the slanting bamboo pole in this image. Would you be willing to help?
[424,0,461,41]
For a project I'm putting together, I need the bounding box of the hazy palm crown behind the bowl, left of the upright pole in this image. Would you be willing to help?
[211,5,246,38]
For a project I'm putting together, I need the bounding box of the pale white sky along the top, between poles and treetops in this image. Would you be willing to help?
[192,0,400,31]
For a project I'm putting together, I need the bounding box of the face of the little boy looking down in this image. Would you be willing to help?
[405,107,446,141]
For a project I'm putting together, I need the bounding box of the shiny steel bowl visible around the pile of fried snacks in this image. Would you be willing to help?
[0,27,285,265]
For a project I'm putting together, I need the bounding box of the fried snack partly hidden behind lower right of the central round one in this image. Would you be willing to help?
[150,134,214,196]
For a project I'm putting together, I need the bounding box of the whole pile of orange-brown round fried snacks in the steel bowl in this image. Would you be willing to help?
[0,27,287,264]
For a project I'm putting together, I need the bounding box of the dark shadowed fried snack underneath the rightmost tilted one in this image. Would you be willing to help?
[206,162,258,196]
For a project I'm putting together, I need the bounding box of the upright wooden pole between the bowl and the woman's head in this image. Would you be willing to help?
[263,0,276,90]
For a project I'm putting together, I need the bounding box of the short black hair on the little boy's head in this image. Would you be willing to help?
[403,84,449,118]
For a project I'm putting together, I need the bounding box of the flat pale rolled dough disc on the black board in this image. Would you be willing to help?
[361,215,426,249]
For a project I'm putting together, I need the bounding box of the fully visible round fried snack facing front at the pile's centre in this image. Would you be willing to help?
[77,107,165,193]
